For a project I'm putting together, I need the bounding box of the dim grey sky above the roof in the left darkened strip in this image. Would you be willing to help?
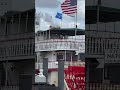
[0,0,35,16]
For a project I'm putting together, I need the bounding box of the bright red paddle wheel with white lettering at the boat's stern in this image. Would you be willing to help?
[65,66,85,90]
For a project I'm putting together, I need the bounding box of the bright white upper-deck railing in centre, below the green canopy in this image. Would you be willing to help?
[35,39,85,52]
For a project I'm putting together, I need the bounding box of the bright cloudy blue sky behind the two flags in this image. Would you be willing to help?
[35,0,85,31]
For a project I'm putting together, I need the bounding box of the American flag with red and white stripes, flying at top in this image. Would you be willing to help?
[61,0,77,15]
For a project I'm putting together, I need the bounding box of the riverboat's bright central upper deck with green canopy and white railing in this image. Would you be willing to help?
[35,29,85,52]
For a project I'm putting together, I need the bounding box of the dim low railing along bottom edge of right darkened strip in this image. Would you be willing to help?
[86,84,120,90]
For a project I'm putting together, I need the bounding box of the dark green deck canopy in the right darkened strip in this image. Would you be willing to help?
[85,6,120,24]
